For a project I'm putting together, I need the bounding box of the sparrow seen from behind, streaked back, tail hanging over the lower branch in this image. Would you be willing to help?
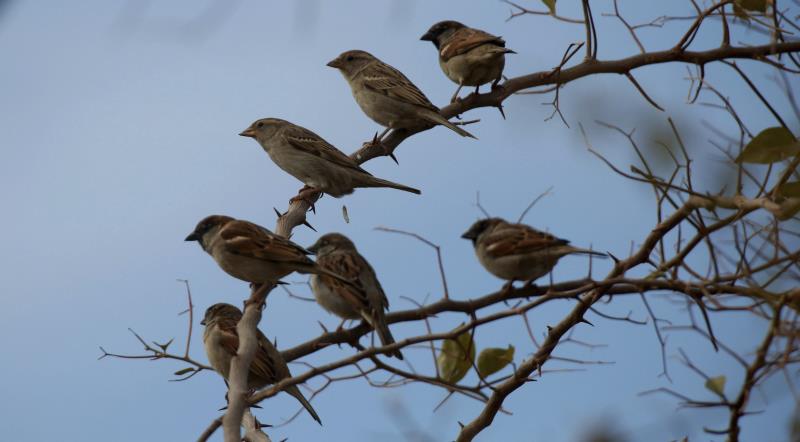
[308,233,403,359]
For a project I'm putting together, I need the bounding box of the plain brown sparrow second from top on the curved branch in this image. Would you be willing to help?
[328,50,475,141]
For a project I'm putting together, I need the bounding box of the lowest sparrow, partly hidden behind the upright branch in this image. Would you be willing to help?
[200,303,322,425]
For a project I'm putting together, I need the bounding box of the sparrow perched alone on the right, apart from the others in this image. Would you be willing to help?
[461,218,606,282]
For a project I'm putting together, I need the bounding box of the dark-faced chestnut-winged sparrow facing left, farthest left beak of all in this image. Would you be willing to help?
[186,215,350,284]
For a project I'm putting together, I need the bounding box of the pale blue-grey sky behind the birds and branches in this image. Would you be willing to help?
[0,0,797,442]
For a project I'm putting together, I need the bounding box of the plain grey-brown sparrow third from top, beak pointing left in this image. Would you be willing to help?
[239,118,421,198]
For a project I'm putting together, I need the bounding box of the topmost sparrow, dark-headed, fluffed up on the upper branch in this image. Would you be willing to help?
[420,20,516,102]
